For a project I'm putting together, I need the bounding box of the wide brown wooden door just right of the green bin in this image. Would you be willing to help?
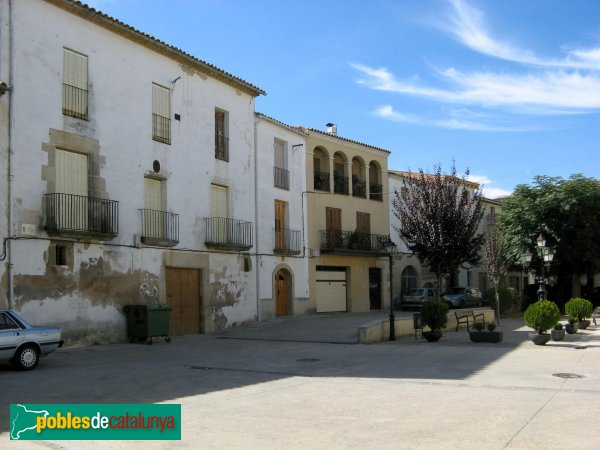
[166,267,202,336]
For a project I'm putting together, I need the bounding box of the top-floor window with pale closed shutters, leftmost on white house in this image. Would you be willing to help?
[63,48,88,120]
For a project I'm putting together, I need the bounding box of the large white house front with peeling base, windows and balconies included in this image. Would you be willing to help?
[0,0,264,343]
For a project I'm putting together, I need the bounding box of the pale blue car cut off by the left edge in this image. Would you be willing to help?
[0,310,63,370]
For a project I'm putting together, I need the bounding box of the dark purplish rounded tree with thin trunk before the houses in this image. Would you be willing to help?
[392,163,484,300]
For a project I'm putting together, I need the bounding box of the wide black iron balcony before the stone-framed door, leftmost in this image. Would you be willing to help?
[44,194,119,239]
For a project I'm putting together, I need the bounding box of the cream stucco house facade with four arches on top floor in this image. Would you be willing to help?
[304,129,390,312]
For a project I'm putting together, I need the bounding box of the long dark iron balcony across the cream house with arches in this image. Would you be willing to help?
[321,230,390,255]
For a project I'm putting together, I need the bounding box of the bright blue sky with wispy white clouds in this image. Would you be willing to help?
[88,0,600,197]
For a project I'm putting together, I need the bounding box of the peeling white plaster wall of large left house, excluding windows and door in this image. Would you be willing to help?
[0,1,256,343]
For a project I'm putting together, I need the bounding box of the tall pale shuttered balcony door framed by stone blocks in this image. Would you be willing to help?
[53,149,88,230]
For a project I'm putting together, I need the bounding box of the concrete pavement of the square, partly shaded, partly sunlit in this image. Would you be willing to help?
[0,314,600,449]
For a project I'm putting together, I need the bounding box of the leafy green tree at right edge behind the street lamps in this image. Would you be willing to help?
[500,174,600,301]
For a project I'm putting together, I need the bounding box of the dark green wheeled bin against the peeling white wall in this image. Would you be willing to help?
[123,305,171,345]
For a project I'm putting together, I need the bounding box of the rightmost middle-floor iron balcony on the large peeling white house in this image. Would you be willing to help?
[204,217,253,250]
